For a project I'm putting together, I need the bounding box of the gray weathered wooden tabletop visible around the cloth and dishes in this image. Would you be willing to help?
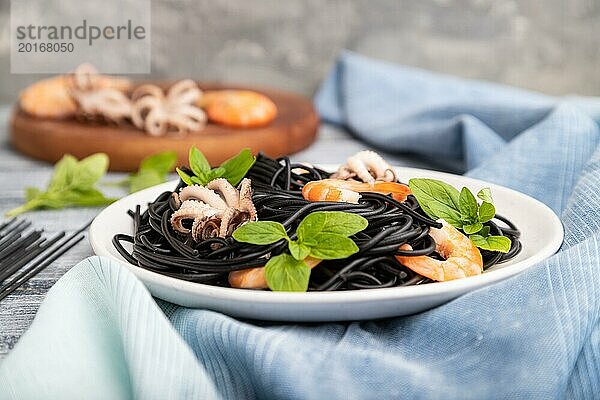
[0,107,435,359]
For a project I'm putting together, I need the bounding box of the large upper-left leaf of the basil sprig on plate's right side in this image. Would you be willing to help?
[408,178,462,222]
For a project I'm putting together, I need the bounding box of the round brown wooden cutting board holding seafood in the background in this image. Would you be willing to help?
[10,82,319,171]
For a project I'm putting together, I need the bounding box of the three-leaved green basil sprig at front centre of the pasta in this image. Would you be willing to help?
[233,211,368,292]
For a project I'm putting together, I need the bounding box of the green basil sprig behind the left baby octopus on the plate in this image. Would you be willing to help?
[177,147,256,186]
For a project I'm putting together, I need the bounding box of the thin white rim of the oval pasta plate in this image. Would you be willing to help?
[89,164,564,304]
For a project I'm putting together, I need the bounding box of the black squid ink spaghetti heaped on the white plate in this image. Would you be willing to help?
[113,154,521,291]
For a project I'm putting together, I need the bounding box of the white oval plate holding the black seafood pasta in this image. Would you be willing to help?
[90,166,563,321]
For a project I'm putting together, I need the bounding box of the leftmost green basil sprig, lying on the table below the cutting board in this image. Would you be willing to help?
[6,153,116,216]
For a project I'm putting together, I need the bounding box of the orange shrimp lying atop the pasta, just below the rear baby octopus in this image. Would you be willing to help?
[302,179,410,203]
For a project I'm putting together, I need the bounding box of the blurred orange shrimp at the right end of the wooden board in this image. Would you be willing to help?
[198,90,277,128]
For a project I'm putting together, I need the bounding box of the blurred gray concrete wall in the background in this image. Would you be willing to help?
[0,0,600,102]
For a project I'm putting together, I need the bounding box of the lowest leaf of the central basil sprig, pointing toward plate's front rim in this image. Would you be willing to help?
[265,253,310,292]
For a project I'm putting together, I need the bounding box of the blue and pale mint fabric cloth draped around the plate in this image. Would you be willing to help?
[0,53,600,399]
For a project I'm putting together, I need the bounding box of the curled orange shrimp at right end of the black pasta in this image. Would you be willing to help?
[396,219,483,282]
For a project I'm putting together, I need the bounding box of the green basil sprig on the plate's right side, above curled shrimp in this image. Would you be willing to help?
[408,178,511,253]
